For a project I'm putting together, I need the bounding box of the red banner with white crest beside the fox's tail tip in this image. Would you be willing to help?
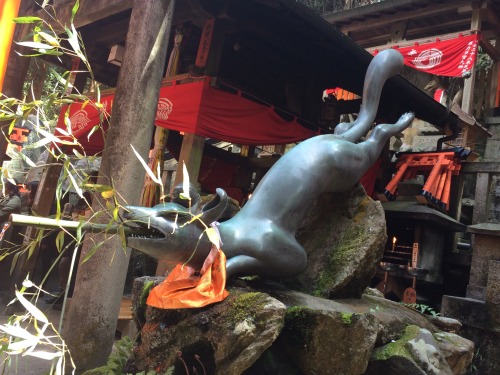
[373,34,479,77]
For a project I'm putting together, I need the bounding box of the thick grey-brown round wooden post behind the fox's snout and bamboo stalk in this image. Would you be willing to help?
[63,0,175,373]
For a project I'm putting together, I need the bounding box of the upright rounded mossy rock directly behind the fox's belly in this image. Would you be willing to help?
[289,184,387,298]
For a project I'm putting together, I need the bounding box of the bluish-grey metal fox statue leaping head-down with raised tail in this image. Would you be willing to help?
[124,49,414,278]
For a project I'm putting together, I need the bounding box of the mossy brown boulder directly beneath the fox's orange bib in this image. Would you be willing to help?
[129,281,286,375]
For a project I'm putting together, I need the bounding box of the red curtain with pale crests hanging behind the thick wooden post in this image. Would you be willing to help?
[56,77,317,154]
